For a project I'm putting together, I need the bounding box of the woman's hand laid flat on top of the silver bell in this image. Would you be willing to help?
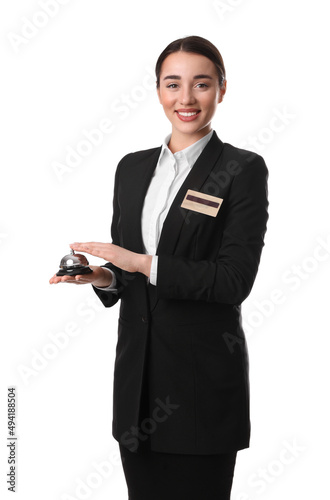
[70,241,152,277]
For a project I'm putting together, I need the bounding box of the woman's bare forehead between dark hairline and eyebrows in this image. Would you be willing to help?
[161,51,216,76]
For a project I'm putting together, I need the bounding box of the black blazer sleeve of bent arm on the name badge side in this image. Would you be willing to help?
[156,155,268,304]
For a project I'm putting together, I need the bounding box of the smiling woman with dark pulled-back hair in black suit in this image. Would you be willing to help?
[50,36,268,500]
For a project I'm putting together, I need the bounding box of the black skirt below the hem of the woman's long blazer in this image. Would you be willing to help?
[119,444,237,500]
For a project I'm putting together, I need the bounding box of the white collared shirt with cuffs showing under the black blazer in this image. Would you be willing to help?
[96,130,213,291]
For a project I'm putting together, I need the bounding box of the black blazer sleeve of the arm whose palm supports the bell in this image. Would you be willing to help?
[92,155,128,307]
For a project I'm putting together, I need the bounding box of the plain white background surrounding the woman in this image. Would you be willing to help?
[0,0,330,500]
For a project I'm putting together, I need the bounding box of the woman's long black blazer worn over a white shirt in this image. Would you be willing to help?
[94,132,268,454]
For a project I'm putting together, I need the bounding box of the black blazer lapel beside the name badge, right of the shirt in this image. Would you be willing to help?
[157,131,223,255]
